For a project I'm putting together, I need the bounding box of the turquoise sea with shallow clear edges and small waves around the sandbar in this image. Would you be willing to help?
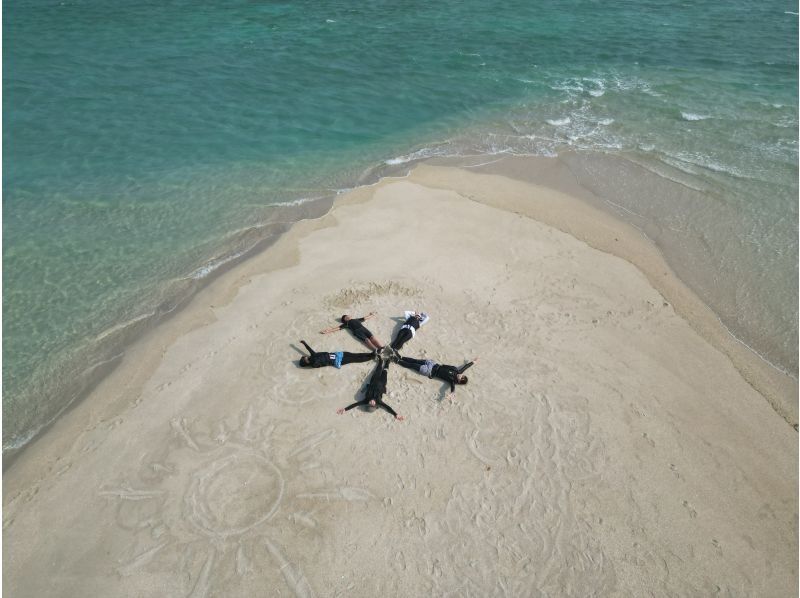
[3,0,798,453]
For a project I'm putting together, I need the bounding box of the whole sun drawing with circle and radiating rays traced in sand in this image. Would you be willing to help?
[100,408,372,598]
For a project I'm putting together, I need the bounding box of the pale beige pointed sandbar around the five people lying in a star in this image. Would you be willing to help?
[3,166,798,596]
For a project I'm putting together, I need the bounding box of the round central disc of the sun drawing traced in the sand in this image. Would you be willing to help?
[186,452,285,537]
